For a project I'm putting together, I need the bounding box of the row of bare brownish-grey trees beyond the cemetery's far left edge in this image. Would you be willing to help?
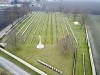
[4,3,32,25]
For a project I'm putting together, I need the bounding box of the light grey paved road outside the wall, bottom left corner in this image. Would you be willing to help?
[0,56,30,75]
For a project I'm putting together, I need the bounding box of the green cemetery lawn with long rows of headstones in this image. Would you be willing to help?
[1,12,92,75]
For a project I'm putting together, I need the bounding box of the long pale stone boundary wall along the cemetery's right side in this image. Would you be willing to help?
[85,27,96,75]
